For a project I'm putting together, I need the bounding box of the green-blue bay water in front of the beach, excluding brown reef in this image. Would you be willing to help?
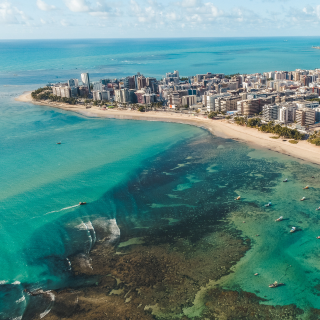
[0,93,320,319]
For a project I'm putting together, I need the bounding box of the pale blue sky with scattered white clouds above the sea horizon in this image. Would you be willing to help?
[0,0,320,39]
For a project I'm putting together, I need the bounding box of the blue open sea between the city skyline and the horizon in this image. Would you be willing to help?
[0,37,320,85]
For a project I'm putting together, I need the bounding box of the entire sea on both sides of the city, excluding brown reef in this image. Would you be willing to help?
[0,37,320,320]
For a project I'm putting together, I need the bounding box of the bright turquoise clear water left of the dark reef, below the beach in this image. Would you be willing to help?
[0,84,202,319]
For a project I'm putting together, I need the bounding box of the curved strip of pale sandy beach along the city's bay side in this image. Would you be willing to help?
[15,91,320,165]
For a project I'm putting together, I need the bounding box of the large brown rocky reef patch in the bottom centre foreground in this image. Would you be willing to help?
[41,230,256,320]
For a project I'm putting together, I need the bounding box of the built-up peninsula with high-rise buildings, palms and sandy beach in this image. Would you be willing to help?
[16,69,320,164]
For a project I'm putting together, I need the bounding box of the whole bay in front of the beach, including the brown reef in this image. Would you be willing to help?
[0,102,320,320]
